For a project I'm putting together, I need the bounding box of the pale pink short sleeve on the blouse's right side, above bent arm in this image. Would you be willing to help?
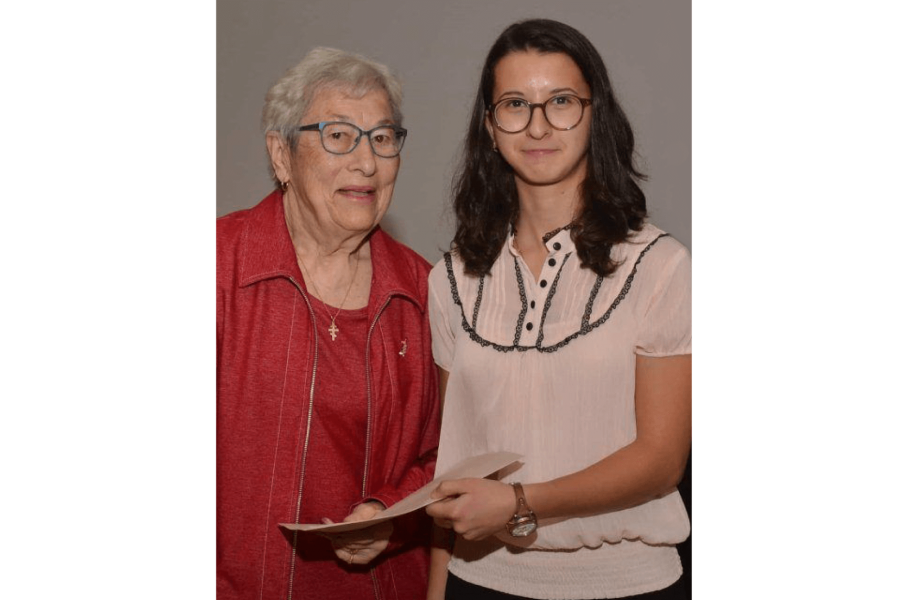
[635,238,694,357]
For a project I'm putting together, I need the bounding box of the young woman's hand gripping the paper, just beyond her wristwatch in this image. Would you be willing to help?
[425,479,516,540]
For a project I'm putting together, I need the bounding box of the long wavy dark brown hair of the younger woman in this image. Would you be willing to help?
[453,19,647,276]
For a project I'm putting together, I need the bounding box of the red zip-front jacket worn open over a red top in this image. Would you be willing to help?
[216,191,439,600]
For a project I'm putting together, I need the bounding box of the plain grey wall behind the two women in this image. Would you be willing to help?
[216,0,694,262]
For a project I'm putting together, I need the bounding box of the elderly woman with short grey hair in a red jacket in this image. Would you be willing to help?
[216,48,439,600]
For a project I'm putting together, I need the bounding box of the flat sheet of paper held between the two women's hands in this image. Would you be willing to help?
[279,452,523,533]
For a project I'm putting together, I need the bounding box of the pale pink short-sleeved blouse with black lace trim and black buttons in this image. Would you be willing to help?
[429,224,694,599]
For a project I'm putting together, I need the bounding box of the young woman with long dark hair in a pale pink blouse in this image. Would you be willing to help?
[427,20,693,600]
